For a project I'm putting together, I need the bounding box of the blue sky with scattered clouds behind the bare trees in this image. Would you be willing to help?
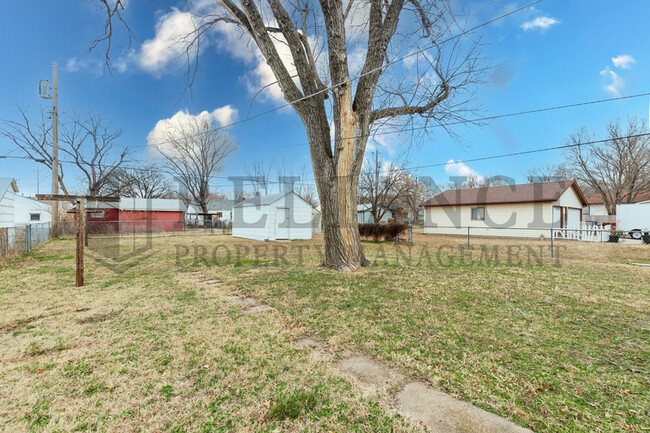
[0,0,650,194]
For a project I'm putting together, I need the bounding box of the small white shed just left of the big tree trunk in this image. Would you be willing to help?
[232,191,313,241]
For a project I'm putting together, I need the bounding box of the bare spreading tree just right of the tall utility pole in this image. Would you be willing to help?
[60,114,129,196]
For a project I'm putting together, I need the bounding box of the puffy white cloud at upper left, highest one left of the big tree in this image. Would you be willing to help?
[135,8,196,77]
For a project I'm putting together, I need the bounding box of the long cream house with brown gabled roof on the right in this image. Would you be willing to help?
[422,181,587,238]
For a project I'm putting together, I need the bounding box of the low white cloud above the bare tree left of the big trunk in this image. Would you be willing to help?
[147,105,237,154]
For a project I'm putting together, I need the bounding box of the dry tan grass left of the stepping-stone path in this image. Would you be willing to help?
[0,242,410,432]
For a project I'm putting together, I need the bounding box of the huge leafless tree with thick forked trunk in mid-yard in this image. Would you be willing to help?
[95,0,483,270]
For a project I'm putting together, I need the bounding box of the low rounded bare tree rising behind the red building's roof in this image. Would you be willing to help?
[102,164,176,198]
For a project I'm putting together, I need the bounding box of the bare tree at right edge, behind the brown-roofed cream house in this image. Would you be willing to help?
[567,117,650,215]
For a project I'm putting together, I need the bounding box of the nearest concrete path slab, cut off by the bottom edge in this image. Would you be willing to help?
[395,382,532,433]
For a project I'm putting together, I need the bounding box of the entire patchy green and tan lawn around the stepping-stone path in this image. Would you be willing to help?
[0,235,650,432]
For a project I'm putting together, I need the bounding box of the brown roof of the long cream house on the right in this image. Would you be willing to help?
[421,181,587,207]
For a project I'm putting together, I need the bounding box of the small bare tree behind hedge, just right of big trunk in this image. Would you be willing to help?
[359,153,408,219]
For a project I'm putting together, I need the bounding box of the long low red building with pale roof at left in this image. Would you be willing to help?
[80,197,187,234]
